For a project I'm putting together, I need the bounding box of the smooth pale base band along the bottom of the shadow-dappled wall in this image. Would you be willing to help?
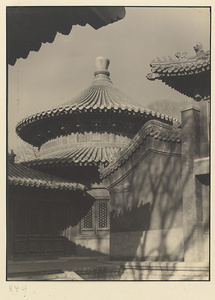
[111,228,183,261]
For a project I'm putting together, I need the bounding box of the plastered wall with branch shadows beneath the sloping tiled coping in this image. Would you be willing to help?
[104,137,184,261]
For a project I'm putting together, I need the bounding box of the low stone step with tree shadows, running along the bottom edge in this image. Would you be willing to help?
[8,261,209,280]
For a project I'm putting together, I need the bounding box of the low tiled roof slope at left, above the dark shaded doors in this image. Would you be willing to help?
[8,163,86,191]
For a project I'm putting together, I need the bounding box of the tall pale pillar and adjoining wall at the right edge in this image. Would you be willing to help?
[181,106,210,262]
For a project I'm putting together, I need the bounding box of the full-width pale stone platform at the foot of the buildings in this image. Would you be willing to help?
[7,257,210,281]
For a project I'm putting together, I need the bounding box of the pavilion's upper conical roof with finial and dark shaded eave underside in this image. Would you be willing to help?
[16,57,176,147]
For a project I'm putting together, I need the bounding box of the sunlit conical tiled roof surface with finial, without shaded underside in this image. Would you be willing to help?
[16,57,178,139]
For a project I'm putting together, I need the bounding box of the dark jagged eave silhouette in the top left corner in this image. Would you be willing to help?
[7,6,125,65]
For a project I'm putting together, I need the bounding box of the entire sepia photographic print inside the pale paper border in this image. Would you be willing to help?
[5,3,212,282]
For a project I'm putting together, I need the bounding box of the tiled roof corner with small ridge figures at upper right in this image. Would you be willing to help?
[147,43,210,80]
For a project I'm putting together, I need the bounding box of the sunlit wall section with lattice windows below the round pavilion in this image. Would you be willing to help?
[67,185,110,257]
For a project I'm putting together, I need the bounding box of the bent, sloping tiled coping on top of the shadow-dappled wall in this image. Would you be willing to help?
[99,120,181,178]
